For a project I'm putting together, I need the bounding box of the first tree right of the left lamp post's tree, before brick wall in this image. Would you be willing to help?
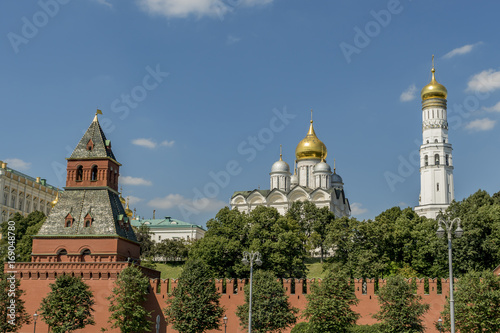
[304,272,359,333]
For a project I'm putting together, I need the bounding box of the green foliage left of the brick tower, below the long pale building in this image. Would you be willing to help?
[0,211,45,262]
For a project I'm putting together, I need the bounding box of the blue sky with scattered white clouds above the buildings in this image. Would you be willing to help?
[0,0,500,224]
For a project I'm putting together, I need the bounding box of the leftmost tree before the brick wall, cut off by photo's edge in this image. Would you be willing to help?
[0,267,31,332]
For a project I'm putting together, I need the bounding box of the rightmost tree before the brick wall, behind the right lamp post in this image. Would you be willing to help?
[441,271,500,333]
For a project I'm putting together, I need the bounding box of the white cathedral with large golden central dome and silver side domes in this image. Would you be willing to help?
[231,119,351,217]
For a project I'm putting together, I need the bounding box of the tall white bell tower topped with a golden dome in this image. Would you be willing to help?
[415,60,455,219]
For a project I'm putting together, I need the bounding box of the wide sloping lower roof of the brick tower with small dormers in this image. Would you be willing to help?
[37,188,137,242]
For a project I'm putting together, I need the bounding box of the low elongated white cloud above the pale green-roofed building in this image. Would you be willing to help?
[148,194,227,213]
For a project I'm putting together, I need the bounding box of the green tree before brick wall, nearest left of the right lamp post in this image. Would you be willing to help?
[373,275,429,333]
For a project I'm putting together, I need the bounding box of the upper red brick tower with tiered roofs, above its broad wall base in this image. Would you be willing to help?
[32,114,140,262]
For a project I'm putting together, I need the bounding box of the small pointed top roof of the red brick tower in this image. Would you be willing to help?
[69,115,116,161]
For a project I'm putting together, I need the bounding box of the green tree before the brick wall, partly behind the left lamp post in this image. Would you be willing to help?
[236,270,298,333]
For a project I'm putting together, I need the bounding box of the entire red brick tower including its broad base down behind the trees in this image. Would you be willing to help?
[8,111,161,333]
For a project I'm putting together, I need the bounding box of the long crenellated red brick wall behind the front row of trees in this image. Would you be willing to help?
[11,272,449,333]
